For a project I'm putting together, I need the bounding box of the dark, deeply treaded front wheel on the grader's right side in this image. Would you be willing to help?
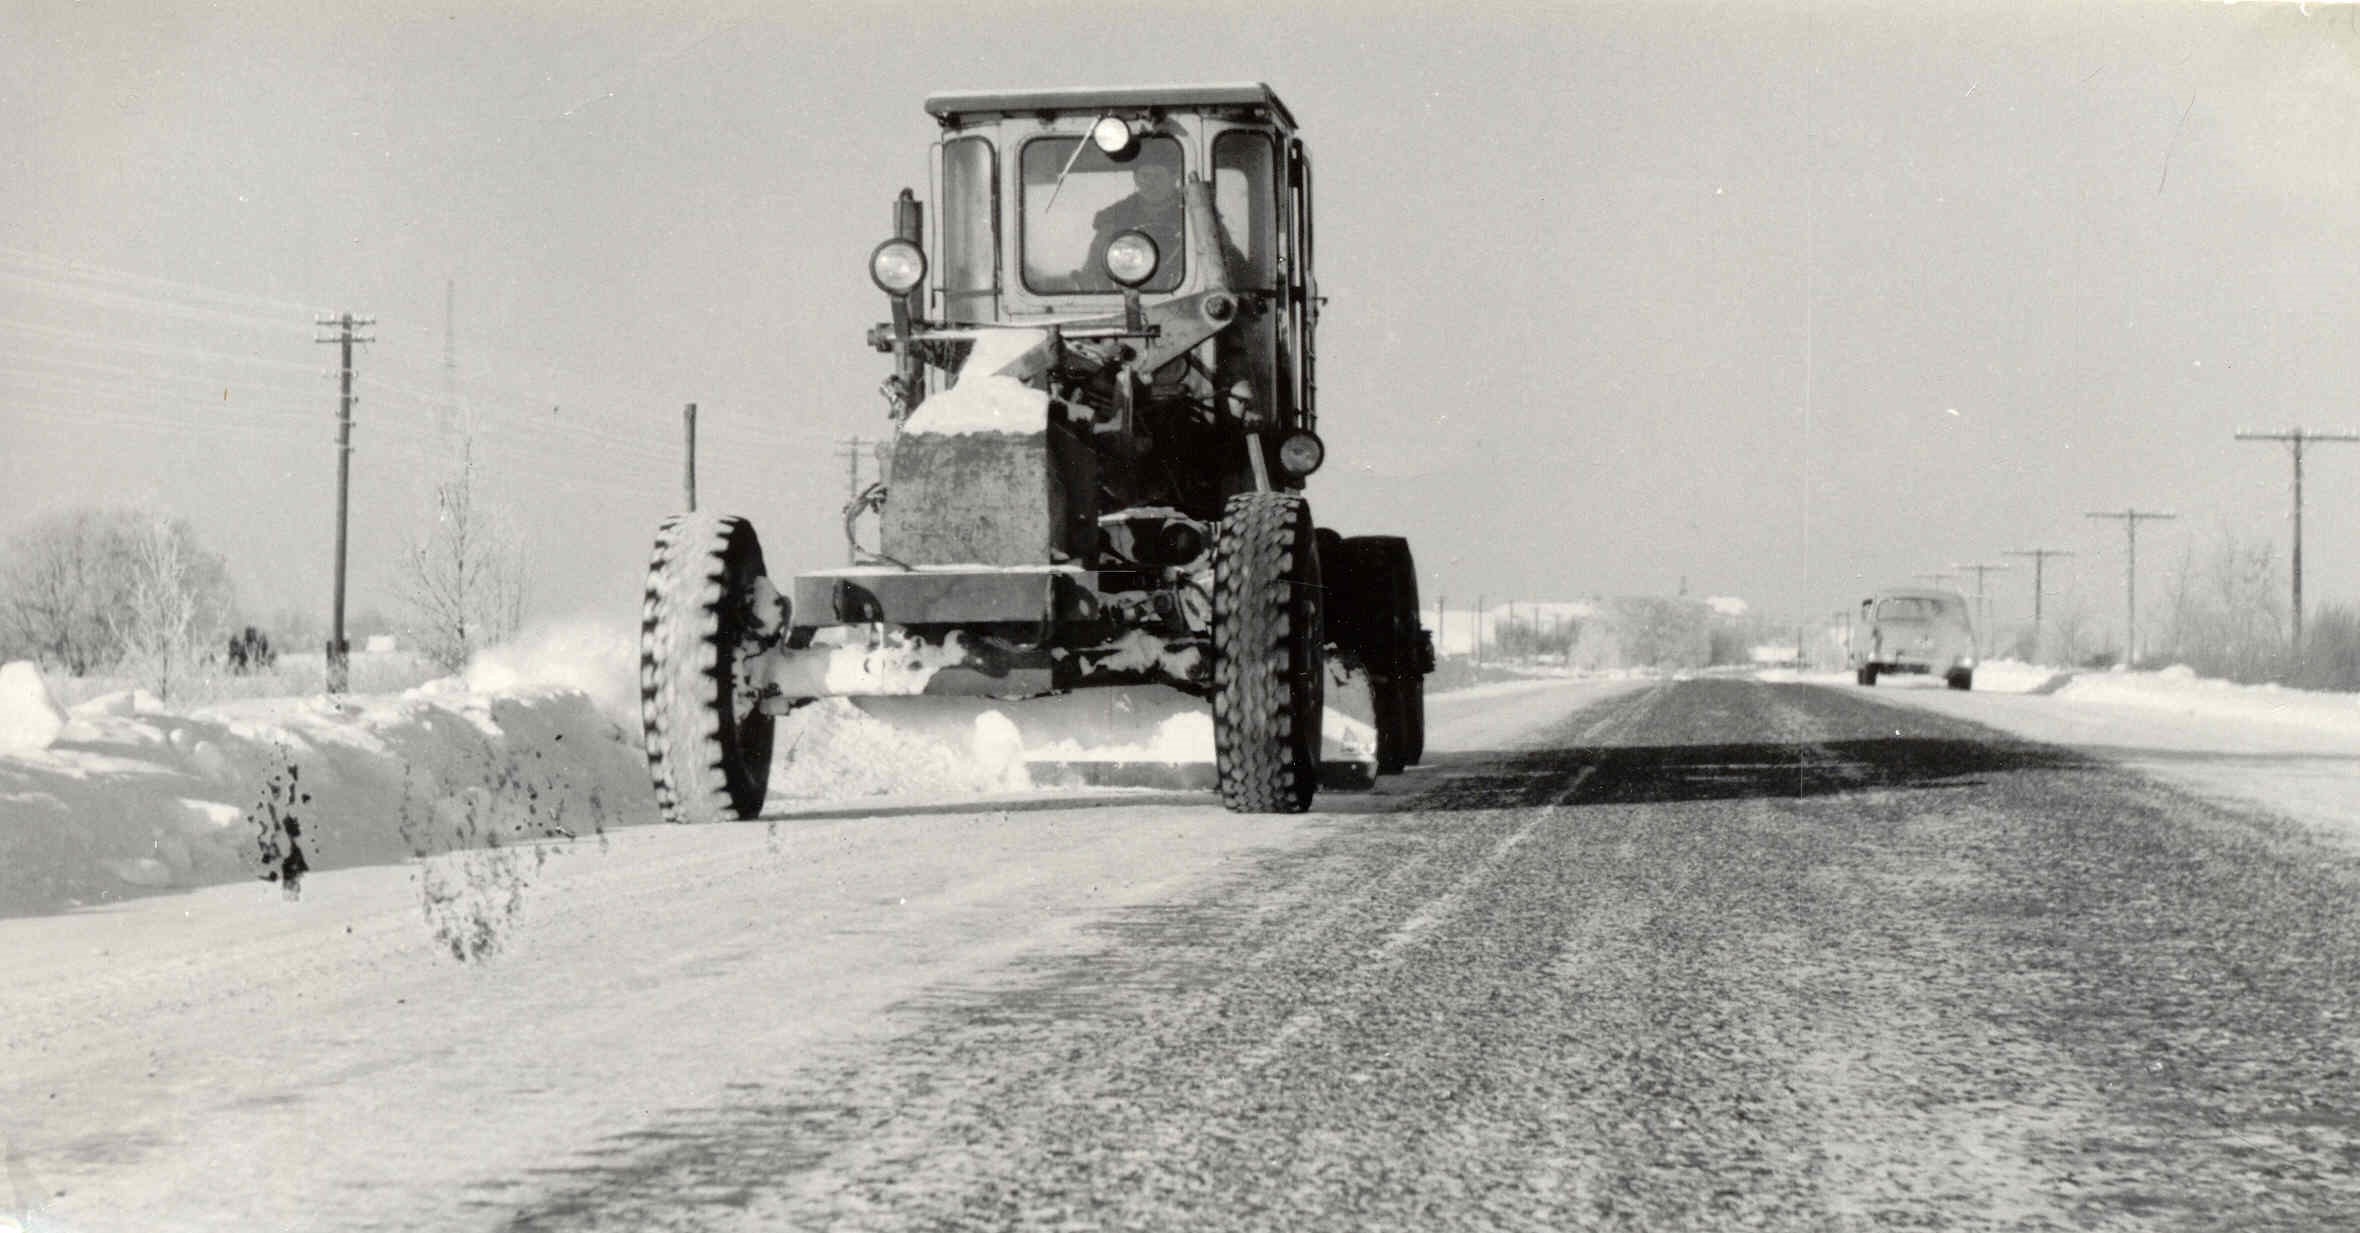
[1213,491,1326,813]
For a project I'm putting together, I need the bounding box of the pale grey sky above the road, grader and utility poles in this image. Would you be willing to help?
[0,0,2360,637]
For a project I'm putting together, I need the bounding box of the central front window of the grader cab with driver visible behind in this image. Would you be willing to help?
[1022,137,1187,293]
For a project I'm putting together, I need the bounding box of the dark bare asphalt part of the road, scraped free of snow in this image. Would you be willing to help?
[505,680,2360,1231]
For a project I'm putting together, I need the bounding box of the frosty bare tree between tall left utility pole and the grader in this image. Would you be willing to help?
[396,442,526,671]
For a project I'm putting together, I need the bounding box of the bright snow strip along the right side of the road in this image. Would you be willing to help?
[1761,661,2360,848]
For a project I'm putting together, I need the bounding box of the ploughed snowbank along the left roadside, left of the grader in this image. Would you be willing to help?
[0,680,654,916]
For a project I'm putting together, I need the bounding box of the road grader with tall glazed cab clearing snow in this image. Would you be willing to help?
[640,85,1433,822]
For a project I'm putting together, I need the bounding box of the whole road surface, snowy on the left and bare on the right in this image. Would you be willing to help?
[0,680,2360,1233]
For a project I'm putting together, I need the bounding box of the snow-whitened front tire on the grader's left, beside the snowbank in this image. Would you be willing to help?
[640,513,776,822]
